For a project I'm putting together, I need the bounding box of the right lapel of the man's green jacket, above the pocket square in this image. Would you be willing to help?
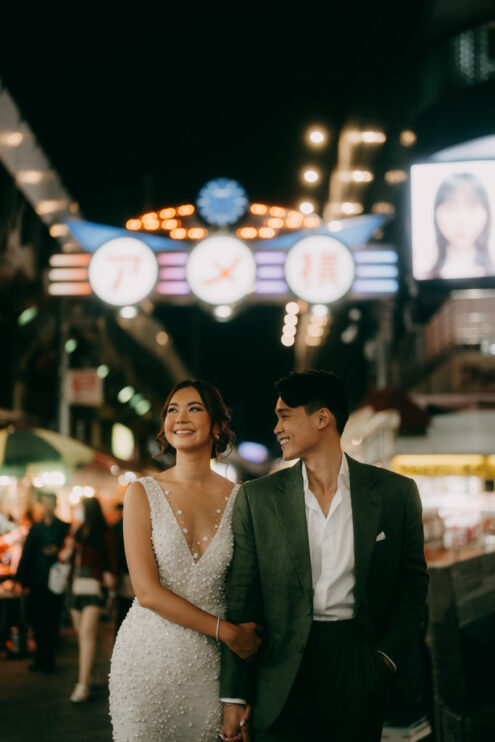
[346,454,382,603]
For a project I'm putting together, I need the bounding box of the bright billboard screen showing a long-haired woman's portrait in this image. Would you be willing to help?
[411,160,495,281]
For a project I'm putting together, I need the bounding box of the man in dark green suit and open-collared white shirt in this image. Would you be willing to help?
[220,371,428,742]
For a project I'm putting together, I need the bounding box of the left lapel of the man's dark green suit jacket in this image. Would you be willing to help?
[273,462,313,600]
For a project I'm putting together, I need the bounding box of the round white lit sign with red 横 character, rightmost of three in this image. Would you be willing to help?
[285,235,355,304]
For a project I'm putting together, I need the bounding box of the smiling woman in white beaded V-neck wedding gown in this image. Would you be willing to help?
[110,380,260,742]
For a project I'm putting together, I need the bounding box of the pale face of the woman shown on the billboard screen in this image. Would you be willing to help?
[435,186,488,250]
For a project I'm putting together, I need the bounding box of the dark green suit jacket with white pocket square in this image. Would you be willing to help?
[220,456,428,729]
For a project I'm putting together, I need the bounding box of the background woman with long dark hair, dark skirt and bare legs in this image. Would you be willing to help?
[59,497,117,703]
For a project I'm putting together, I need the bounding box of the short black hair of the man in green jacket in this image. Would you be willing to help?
[275,369,349,435]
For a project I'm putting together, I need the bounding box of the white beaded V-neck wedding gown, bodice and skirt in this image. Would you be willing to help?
[110,477,239,742]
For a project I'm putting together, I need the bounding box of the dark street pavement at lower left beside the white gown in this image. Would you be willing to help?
[0,621,113,742]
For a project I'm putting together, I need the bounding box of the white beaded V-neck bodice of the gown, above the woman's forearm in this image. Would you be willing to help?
[138,477,239,615]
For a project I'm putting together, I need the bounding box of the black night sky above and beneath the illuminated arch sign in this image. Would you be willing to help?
[0,0,428,454]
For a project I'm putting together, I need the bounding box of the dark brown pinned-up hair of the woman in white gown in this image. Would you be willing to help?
[156,379,235,456]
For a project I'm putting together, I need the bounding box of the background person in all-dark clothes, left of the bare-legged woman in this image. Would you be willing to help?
[16,492,69,673]
